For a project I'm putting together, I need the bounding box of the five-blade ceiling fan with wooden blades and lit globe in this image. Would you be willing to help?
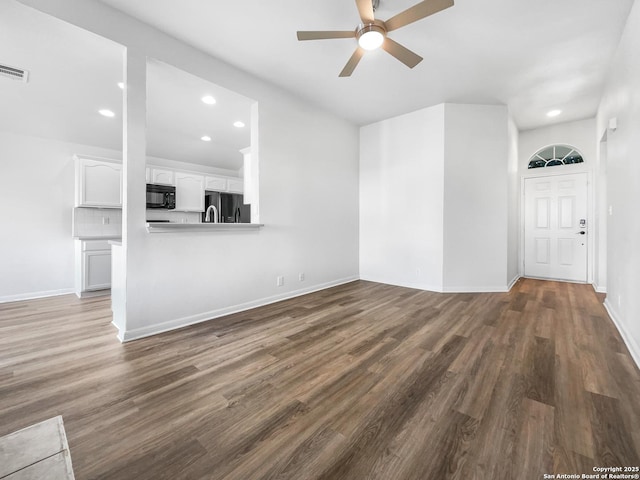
[298,0,453,77]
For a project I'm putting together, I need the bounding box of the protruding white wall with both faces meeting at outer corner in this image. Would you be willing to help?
[360,104,510,291]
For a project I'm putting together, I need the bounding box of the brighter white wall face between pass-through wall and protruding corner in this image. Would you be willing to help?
[360,105,444,291]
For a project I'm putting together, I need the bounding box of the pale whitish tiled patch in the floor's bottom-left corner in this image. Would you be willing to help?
[0,416,74,480]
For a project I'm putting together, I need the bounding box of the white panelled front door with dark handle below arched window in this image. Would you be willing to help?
[524,173,589,283]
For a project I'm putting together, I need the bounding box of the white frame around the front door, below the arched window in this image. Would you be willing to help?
[518,168,598,285]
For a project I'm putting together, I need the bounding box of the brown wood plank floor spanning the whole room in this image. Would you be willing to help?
[0,279,640,480]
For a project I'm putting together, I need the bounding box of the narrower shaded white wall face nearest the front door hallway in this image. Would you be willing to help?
[444,103,508,291]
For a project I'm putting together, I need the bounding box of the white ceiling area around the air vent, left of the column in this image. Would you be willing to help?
[0,1,123,150]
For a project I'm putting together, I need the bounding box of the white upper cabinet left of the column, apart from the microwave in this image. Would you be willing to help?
[75,156,122,208]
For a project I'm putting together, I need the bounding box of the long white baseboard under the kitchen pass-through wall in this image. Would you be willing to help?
[118,275,359,342]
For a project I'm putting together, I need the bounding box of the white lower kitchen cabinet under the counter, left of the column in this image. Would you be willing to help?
[75,240,111,297]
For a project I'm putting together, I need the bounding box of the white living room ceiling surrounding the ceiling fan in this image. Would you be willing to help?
[96,0,633,129]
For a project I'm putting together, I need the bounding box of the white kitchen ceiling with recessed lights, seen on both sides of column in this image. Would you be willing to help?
[0,0,253,171]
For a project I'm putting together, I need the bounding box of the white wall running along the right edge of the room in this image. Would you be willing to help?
[594,1,640,365]
